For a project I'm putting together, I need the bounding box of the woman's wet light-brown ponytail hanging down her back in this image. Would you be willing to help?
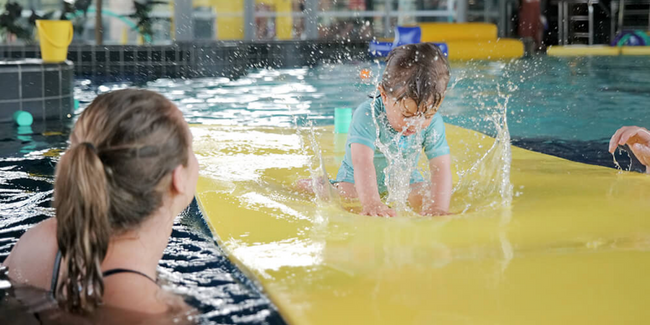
[54,142,111,313]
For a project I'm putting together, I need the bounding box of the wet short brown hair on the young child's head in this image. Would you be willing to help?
[381,43,450,115]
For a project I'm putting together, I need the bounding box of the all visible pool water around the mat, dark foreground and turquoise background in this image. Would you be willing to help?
[0,57,650,324]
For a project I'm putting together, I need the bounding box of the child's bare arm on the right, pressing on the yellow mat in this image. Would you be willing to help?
[420,155,452,215]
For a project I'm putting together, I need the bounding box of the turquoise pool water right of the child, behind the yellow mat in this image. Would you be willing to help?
[444,57,650,141]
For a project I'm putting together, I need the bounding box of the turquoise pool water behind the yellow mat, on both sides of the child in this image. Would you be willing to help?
[78,57,650,141]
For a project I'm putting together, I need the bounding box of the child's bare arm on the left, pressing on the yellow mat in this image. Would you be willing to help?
[351,143,395,217]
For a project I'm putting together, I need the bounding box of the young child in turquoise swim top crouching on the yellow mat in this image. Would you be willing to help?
[299,43,452,216]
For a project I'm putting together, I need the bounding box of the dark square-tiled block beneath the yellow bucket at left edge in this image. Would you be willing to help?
[0,60,74,122]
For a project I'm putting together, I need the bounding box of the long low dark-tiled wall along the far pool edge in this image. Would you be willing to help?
[0,41,368,81]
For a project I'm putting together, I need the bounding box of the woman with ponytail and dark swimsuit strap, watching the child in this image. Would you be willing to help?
[4,89,198,314]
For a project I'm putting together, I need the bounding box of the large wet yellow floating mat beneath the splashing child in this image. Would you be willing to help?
[192,125,650,325]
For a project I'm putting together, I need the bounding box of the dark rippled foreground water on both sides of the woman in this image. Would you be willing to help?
[0,123,284,324]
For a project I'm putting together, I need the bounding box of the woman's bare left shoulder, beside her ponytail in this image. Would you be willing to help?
[4,218,58,289]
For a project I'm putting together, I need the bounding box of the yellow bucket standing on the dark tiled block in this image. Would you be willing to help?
[36,20,74,62]
